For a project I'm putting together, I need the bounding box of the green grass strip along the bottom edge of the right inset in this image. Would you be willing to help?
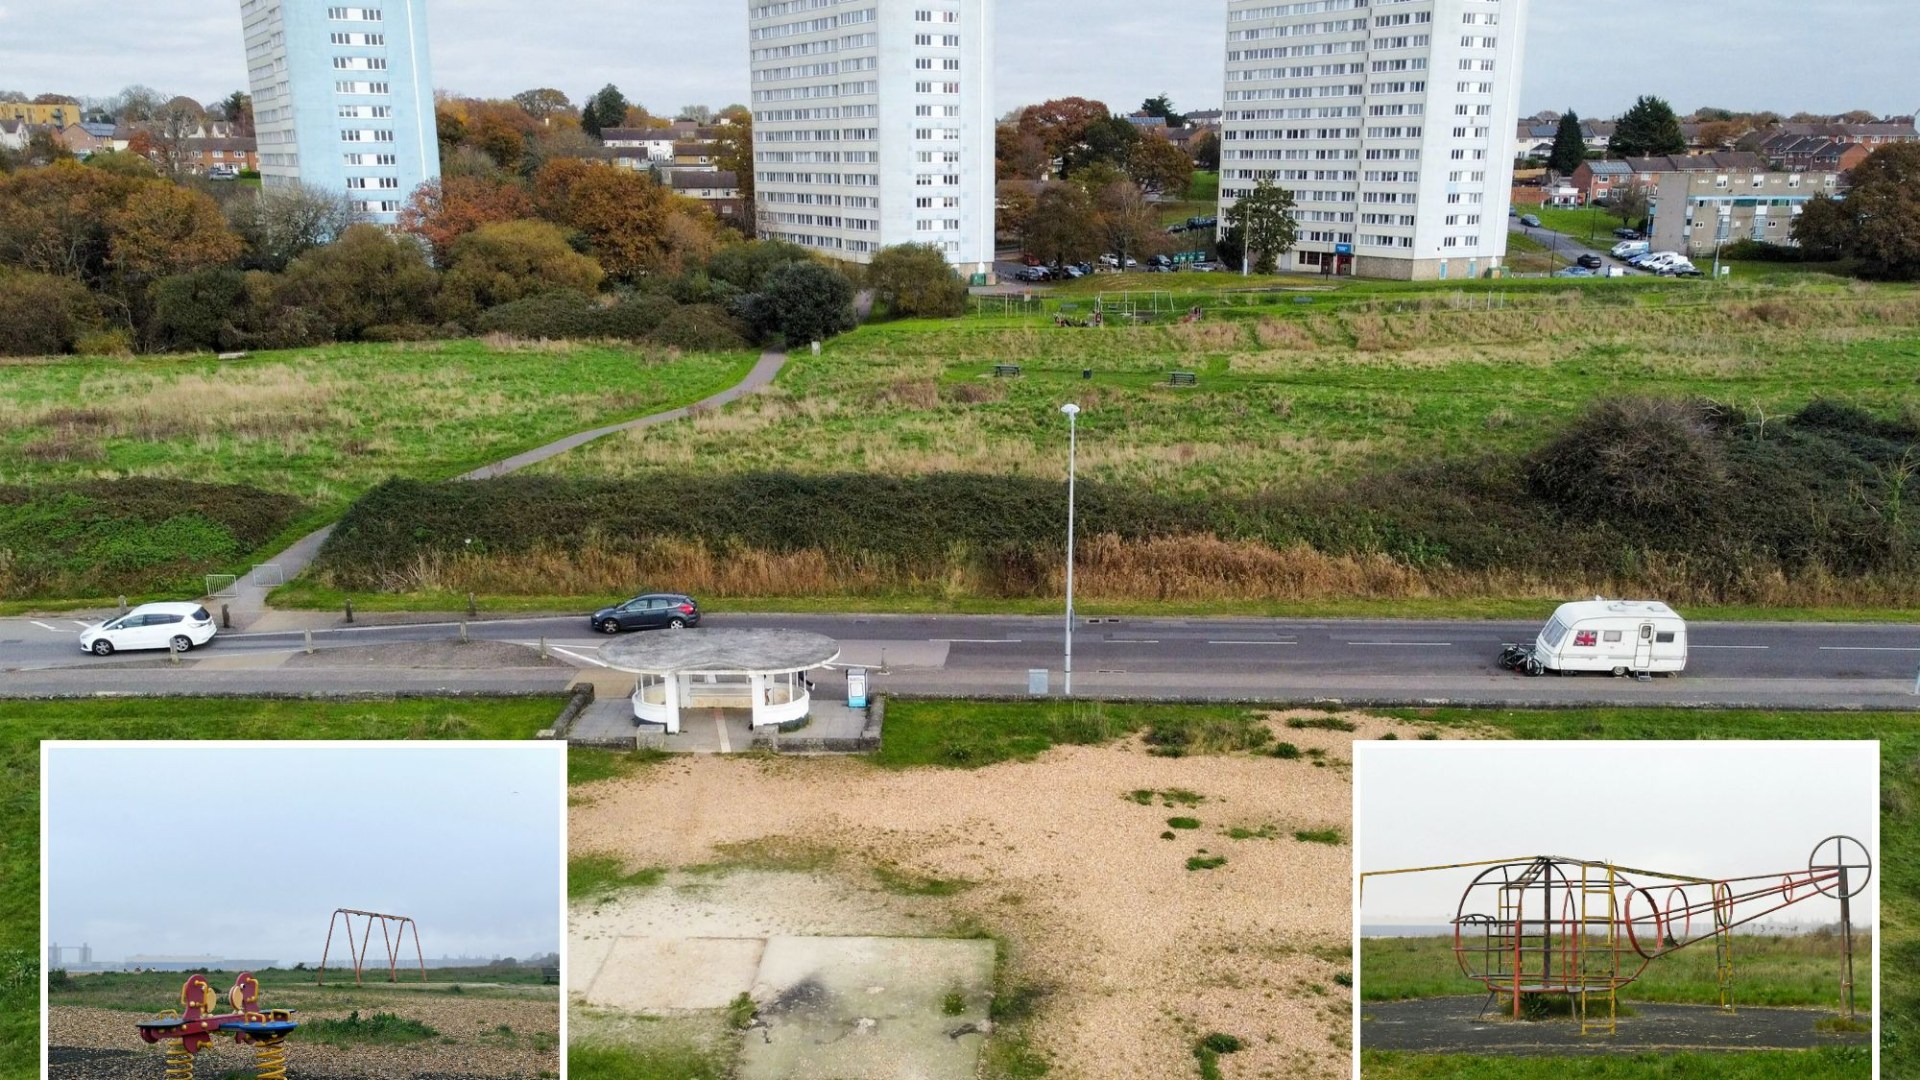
[1359,1045,1873,1080]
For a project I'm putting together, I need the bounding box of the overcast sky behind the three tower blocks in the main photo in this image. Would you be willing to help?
[0,0,1920,117]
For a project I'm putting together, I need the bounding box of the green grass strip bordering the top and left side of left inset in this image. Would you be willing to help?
[0,698,564,1078]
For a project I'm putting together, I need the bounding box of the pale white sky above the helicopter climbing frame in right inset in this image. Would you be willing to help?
[1354,742,1880,926]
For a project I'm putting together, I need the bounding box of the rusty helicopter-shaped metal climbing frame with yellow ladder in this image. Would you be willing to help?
[1359,836,1874,1036]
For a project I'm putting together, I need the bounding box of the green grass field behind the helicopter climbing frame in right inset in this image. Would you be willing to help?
[1359,934,1874,1013]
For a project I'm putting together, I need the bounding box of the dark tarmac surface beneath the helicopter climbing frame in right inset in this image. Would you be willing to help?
[1359,994,1872,1057]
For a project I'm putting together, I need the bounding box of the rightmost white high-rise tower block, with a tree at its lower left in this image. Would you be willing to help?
[1219,0,1528,281]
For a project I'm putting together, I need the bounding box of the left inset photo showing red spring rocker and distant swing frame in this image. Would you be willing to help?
[40,742,566,1080]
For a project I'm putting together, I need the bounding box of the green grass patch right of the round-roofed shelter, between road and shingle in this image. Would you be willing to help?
[876,700,1267,764]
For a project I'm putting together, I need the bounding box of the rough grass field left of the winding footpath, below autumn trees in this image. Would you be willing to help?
[0,340,755,611]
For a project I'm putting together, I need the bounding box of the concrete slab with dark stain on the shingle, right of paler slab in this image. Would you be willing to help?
[739,938,995,1080]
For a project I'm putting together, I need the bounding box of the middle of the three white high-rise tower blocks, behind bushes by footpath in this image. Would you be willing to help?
[747,0,995,273]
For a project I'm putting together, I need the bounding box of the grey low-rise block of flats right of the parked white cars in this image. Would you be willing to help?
[1632,164,1839,256]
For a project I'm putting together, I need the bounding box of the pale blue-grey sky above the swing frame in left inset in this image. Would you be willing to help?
[42,742,564,967]
